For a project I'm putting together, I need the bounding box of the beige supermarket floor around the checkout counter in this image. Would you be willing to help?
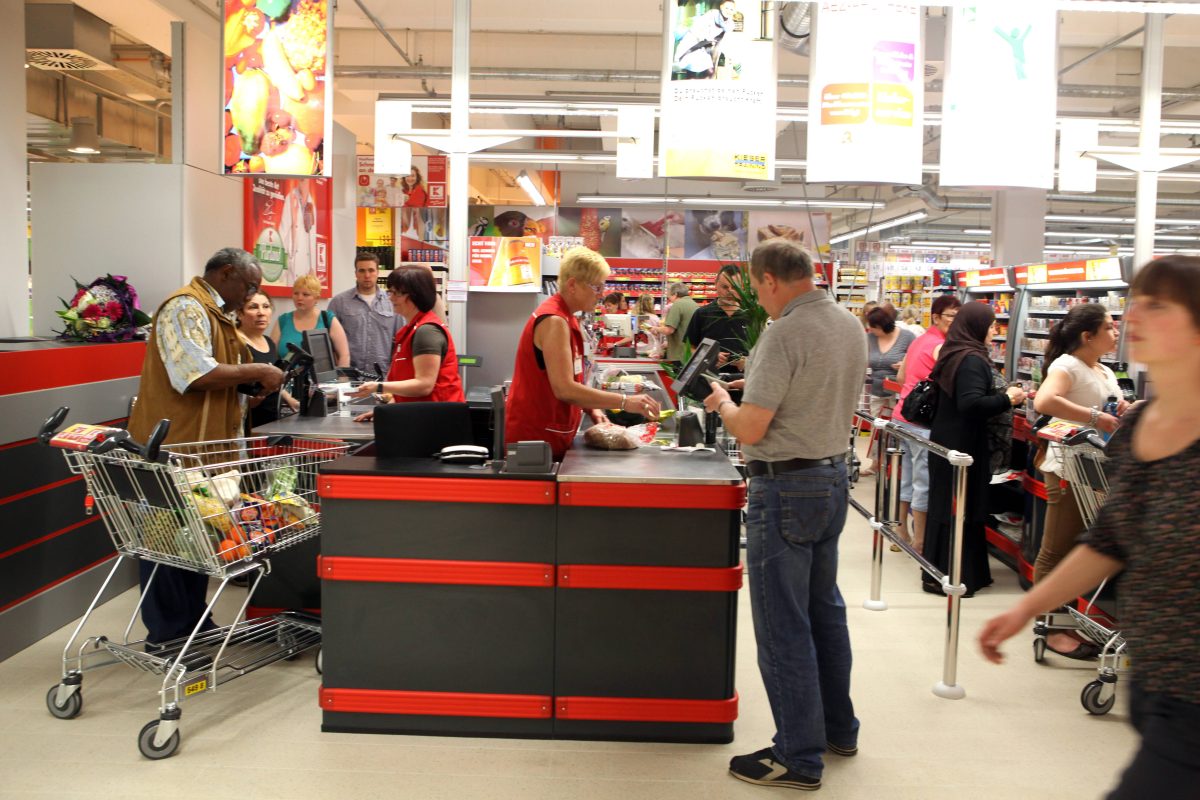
[0,483,1135,800]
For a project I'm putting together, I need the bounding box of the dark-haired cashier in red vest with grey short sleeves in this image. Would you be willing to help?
[352,265,466,422]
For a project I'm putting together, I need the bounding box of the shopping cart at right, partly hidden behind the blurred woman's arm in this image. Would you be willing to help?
[1033,428,1129,715]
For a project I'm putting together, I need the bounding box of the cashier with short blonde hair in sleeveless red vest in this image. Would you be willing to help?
[504,247,659,461]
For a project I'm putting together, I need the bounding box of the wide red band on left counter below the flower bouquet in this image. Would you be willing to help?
[0,342,146,395]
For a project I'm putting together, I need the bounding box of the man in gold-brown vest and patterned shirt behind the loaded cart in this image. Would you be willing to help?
[130,247,283,650]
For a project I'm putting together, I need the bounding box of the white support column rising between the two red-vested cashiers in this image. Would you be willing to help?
[446,0,470,353]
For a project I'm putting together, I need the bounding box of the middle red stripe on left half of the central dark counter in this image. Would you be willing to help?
[317,555,554,587]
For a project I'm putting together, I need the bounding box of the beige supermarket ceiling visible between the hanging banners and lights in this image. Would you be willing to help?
[31,0,1200,237]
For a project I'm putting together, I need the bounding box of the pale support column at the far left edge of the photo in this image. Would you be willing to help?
[0,2,30,336]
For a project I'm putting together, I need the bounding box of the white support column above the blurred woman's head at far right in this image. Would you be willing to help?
[1133,14,1165,269]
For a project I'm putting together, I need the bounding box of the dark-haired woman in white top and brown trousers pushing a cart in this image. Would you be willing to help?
[1033,303,1128,658]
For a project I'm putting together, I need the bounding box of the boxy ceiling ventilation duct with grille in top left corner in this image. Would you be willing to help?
[25,2,116,72]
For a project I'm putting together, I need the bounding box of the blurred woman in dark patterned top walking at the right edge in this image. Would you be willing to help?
[979,255,1200,800]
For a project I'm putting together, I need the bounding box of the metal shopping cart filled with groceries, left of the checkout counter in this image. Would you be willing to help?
[38,408,348,759]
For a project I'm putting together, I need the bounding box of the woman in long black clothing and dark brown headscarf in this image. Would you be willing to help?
[922,302,1025,597]
